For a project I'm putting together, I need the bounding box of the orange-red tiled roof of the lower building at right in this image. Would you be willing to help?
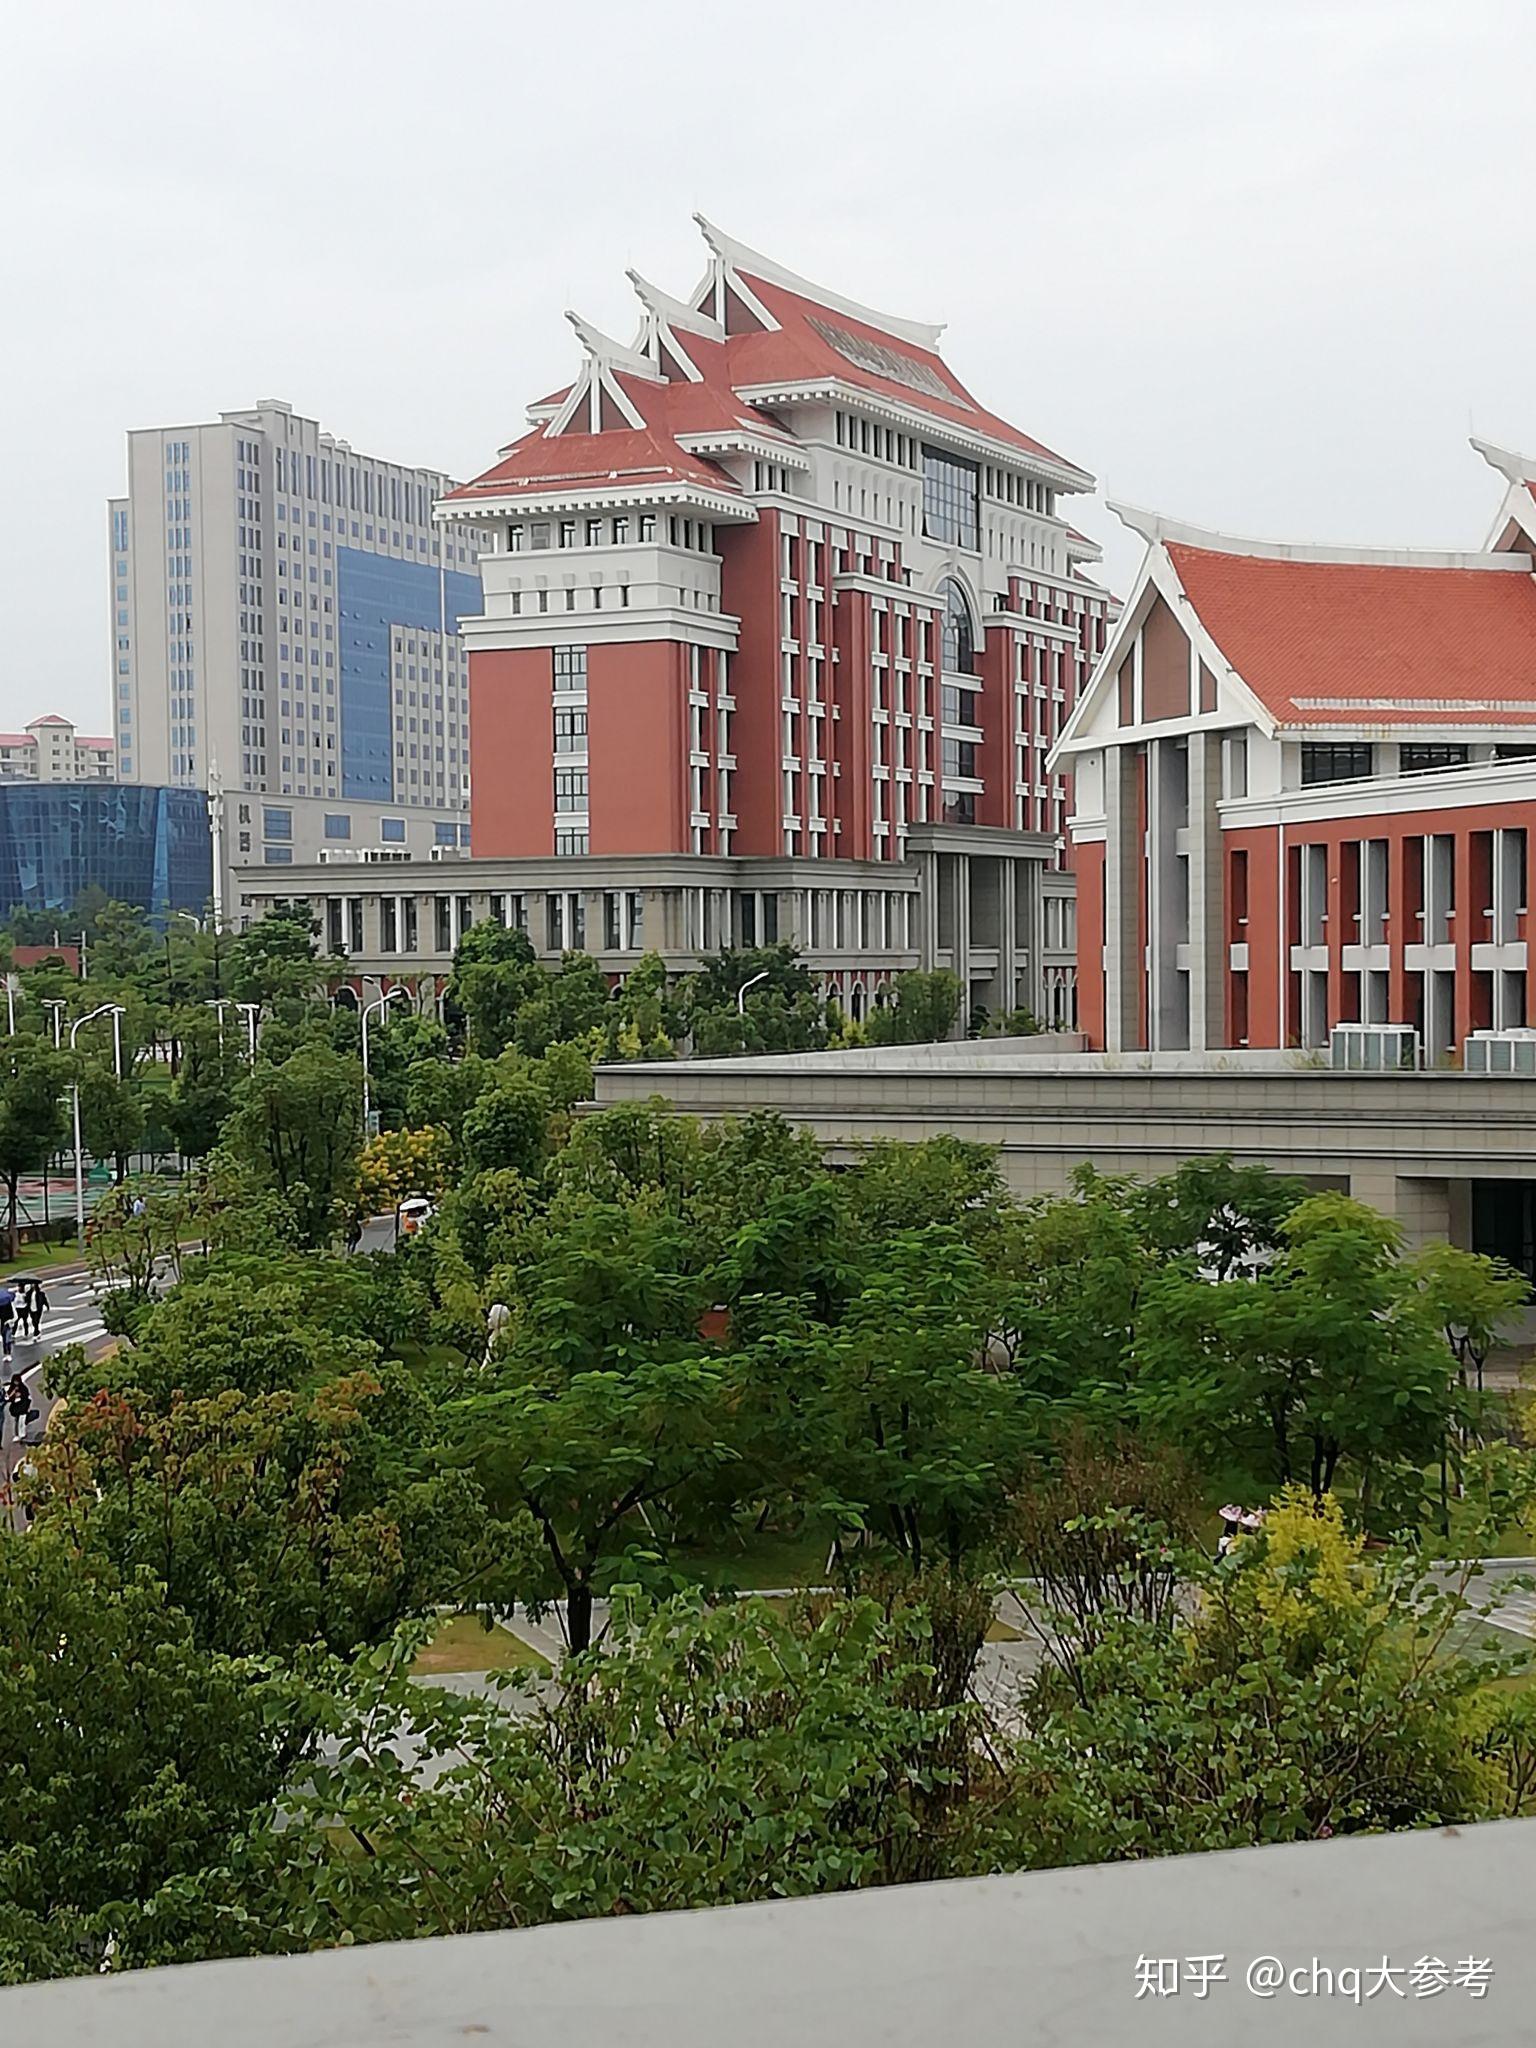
[1167,541,1536,725]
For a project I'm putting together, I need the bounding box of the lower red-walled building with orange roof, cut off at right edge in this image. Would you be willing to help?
[1055,442,1536,1071]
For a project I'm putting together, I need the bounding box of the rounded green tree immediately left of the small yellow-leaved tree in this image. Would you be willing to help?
[225,1042,362,1245]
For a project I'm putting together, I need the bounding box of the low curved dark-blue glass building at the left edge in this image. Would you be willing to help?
[0,782,213,920]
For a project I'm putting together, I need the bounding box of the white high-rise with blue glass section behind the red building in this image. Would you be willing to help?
[109,399,483,911]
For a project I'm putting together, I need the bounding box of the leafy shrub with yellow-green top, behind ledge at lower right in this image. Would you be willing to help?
[1012,1493,1499,1864]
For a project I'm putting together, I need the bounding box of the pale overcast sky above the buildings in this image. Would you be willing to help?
[0,0,1536,729]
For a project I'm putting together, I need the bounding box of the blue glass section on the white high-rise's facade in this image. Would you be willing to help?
[336,547,483,803]
